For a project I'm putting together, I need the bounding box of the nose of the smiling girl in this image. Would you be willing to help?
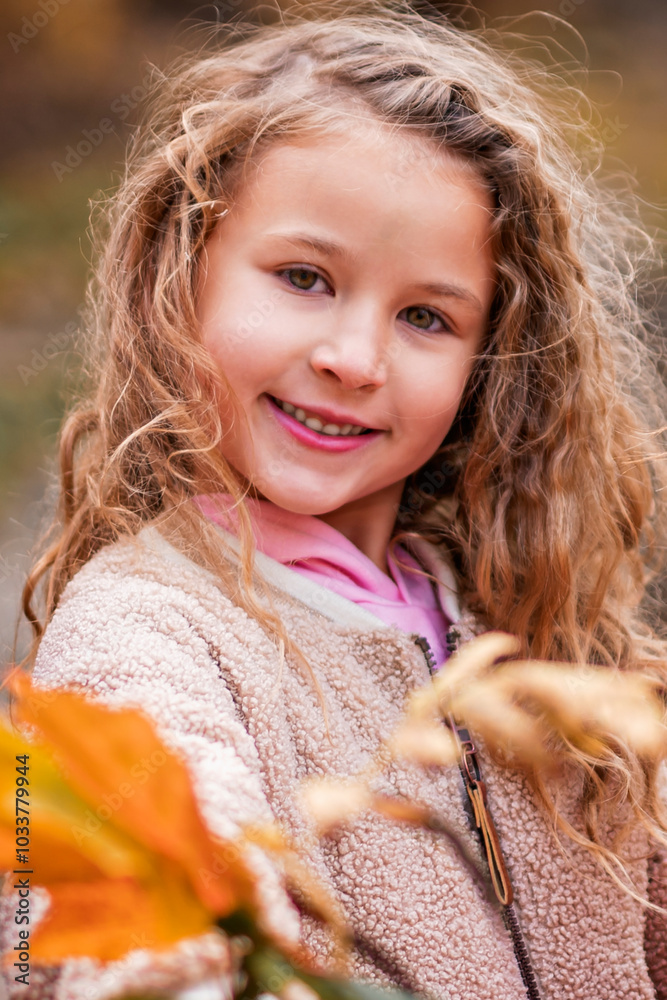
[310,300,392,389]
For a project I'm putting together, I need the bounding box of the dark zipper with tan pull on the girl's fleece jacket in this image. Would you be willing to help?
[412,626,542,1000]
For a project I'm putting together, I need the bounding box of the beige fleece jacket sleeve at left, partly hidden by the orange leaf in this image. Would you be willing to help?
[21,530,299,1000]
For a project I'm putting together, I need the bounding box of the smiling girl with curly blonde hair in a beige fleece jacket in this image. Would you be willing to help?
[7,9,667,1000]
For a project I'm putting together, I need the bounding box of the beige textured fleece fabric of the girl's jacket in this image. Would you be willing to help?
[1,529,667,1000]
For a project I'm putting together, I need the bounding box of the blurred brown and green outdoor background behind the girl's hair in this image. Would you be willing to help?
[0,0,667,662]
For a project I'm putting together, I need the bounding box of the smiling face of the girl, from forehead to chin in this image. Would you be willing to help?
[198,124,494,515]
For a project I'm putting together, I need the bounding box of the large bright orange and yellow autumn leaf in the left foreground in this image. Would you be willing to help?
[0,677,255,962]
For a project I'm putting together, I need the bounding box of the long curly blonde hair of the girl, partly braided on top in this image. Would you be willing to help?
[24,4,667,900]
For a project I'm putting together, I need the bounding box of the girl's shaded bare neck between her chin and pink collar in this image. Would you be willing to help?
[317,482,403,575]
